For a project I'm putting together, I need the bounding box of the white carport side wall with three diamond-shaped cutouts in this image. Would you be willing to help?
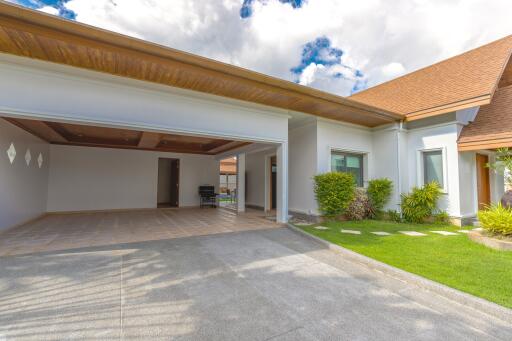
[0,118,49,230]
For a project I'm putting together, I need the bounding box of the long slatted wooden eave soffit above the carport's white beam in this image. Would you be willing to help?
[0,2,403,127]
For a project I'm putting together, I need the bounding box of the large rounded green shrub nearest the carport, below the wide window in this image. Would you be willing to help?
[314,172,356,217]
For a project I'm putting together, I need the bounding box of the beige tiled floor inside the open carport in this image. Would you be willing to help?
[0,208,281,257]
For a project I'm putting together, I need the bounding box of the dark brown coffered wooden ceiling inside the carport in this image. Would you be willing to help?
[4,117,250,155]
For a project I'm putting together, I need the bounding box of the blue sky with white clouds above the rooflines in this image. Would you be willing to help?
[9,0,512,96]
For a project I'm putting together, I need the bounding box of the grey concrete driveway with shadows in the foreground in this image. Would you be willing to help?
[0,228,512,341]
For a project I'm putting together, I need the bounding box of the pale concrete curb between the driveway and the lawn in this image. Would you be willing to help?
[287,224,512,323]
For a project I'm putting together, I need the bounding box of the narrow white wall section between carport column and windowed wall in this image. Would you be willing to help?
[288,120,318,214]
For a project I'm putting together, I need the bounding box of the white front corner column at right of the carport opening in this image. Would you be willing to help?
[276,142,288,223]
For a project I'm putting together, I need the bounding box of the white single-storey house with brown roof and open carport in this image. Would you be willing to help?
[0,2,512,229]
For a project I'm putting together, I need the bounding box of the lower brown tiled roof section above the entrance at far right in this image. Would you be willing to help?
[458,85,512,151]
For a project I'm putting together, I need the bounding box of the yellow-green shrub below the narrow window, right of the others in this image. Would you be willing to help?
[401,182,441,223]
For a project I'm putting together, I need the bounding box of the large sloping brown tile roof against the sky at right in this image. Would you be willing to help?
[349,35,512,120]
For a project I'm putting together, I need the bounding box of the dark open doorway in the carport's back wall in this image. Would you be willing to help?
[157,158,180,207]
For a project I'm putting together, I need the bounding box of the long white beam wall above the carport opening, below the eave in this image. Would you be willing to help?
[0,54,288,142]
